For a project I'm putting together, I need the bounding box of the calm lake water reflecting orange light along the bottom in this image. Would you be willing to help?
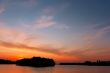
[0,64,110,73]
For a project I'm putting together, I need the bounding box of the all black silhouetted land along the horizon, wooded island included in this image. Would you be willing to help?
[0,57,110,67]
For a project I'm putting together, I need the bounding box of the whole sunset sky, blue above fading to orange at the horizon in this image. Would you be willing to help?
[0,0,110,62]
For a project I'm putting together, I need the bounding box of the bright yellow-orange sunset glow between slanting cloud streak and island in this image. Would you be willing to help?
[2,47,78,62]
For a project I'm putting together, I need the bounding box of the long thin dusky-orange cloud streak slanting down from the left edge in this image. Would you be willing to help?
[0,40,64,54]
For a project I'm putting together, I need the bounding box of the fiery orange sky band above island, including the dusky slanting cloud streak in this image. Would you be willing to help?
[0,42,79,62]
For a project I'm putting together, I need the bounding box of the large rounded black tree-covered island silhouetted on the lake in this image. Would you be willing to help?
[15,57,55,67]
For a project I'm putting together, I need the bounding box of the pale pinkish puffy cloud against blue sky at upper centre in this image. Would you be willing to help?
[26,15,70,30]
